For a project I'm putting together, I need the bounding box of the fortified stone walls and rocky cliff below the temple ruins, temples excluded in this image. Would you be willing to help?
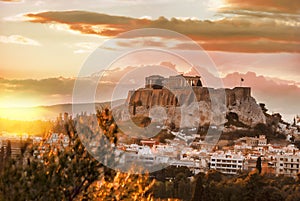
[122,86,266,127]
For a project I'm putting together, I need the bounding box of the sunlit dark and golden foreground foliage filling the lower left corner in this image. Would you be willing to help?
[0,111,154,201]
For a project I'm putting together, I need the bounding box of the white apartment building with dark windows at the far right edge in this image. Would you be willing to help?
[275,153,300,177]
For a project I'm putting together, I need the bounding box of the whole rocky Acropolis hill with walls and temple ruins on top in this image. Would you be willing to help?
[121,75,266,127]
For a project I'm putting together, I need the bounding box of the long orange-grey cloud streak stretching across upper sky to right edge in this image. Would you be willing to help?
[27,11,300,52]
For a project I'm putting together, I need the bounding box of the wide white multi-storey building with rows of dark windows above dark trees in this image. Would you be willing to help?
[210,153,244,174]
